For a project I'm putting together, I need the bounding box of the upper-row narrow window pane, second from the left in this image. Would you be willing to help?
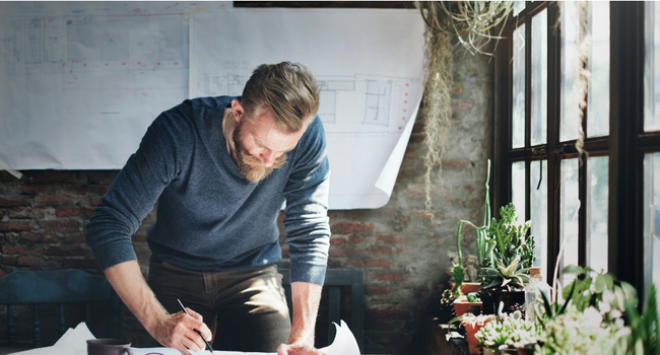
[532,10,548,145]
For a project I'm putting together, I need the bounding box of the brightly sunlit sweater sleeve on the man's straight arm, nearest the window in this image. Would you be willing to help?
[284,116,330,285]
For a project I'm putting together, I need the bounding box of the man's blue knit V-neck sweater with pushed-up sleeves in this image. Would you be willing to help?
[86,96,330,285]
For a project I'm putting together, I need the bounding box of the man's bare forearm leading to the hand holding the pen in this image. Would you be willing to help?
[104,260,168,335]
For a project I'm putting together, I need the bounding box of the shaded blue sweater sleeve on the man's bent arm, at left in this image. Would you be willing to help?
[85,101,194,270]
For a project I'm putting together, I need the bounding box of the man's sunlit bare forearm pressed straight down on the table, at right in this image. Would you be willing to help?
[288,282,323,346]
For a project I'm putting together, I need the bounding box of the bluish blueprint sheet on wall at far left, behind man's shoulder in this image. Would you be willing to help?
[0,2,226,169]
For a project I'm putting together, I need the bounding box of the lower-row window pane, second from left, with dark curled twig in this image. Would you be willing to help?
[529,160,548,278]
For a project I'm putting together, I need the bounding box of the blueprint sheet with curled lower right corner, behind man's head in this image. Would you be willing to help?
[190,9,424,209]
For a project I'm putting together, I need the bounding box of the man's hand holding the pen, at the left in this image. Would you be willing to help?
[147,308,212,354]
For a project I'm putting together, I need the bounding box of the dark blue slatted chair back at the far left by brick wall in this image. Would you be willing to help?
[0,270,119,348]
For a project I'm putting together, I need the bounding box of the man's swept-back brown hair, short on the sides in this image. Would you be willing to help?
[241,62,321,133]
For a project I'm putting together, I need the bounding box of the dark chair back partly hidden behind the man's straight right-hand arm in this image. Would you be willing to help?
[279,268,364,351]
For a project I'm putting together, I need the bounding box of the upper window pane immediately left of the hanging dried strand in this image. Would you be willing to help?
[559,1,579,141]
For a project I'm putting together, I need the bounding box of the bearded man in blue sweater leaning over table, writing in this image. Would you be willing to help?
[86,62,330,355]
